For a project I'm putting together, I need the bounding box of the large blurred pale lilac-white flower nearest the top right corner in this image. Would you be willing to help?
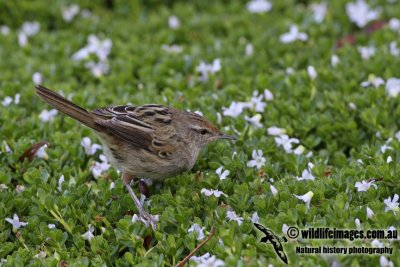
[346,0,380,28]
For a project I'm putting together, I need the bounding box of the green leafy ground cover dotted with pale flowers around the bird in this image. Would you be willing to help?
[0,0,400,266]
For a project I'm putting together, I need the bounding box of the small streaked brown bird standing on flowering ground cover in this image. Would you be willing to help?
[35,85,235,229]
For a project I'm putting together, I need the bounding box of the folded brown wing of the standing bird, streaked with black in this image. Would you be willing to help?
[93,104,179,155]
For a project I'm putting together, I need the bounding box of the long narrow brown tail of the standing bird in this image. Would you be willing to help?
[35,85,100,130]
